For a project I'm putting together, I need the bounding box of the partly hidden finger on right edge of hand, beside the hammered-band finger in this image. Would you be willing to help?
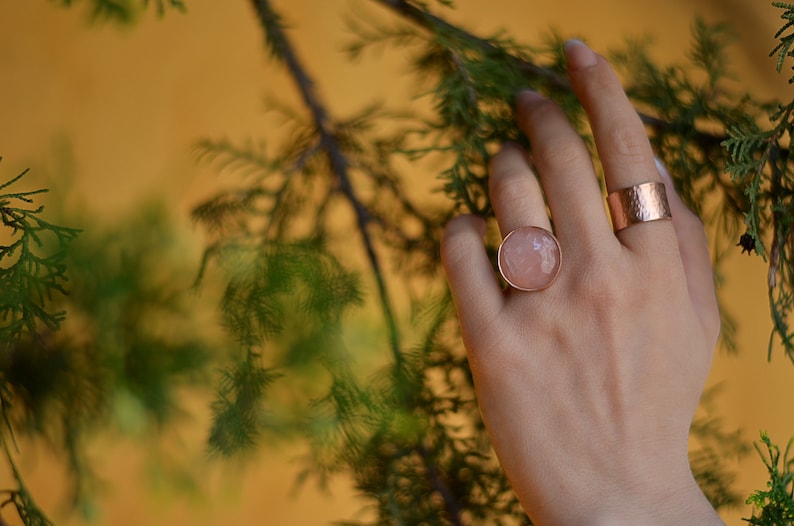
[656,160,720,343]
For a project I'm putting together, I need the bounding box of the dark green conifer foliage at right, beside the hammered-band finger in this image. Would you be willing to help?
[604,17,794,364]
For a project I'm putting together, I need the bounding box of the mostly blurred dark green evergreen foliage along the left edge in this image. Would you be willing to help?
[0,189,217,526]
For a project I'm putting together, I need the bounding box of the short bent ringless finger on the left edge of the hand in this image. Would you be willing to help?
[441,216,504,338]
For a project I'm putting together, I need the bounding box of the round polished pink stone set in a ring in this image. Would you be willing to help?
[498,226,560,290]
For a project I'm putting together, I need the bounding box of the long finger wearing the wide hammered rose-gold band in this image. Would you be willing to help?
[565,40,674,250]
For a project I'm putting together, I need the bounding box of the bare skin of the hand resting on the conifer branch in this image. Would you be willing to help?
[442,41,723,526]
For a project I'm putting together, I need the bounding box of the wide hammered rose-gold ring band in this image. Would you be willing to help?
[607,182,672,232]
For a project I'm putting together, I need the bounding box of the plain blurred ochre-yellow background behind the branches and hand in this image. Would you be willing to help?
[0,0,794,526]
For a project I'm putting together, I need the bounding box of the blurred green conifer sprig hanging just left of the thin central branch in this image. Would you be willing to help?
[204,241,361,456]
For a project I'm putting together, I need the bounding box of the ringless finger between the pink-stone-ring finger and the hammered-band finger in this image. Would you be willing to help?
[516,91,615,252]
